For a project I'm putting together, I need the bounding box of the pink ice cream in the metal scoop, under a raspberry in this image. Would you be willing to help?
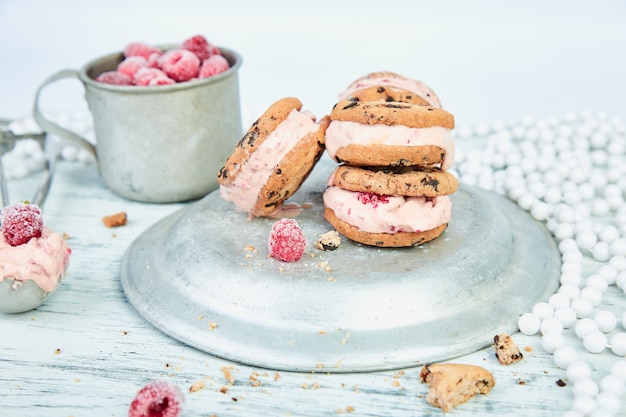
[0,227,71,292]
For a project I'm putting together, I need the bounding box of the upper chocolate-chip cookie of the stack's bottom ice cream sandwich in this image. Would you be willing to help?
[328,165,459,197]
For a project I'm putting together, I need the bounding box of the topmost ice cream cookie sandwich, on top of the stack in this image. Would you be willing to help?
[339,71,441,108]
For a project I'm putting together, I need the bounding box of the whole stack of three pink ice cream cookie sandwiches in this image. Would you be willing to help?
[324,72,458,247]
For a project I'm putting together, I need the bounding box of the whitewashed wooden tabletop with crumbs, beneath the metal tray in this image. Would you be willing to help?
[0,158,626,417]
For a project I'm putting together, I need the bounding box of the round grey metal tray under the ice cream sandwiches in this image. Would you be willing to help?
[121,158,561,372]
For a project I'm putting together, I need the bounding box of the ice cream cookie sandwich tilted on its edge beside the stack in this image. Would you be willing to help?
[218,97,330,217]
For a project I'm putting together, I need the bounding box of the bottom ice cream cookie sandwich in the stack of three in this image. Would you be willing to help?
[323,165,458,247]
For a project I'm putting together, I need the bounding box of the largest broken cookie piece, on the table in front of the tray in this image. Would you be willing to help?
[420,364,496,412]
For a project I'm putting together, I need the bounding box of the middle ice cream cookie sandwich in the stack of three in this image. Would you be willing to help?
[325,100,455,170]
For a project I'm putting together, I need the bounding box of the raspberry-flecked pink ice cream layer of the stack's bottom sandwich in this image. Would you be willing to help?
[324,186,452,234]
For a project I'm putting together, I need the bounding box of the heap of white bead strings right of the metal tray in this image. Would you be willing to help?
[455,112,626,417]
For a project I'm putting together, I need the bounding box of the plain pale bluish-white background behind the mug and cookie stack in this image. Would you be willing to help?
[0,0,626,125]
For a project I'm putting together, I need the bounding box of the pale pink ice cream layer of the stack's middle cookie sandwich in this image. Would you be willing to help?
[326,120,455,171]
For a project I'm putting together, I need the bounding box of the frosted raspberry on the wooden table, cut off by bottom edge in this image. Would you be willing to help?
[128,380,185,417]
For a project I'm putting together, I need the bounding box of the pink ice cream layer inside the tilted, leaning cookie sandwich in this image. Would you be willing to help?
[220,109,319,212]
